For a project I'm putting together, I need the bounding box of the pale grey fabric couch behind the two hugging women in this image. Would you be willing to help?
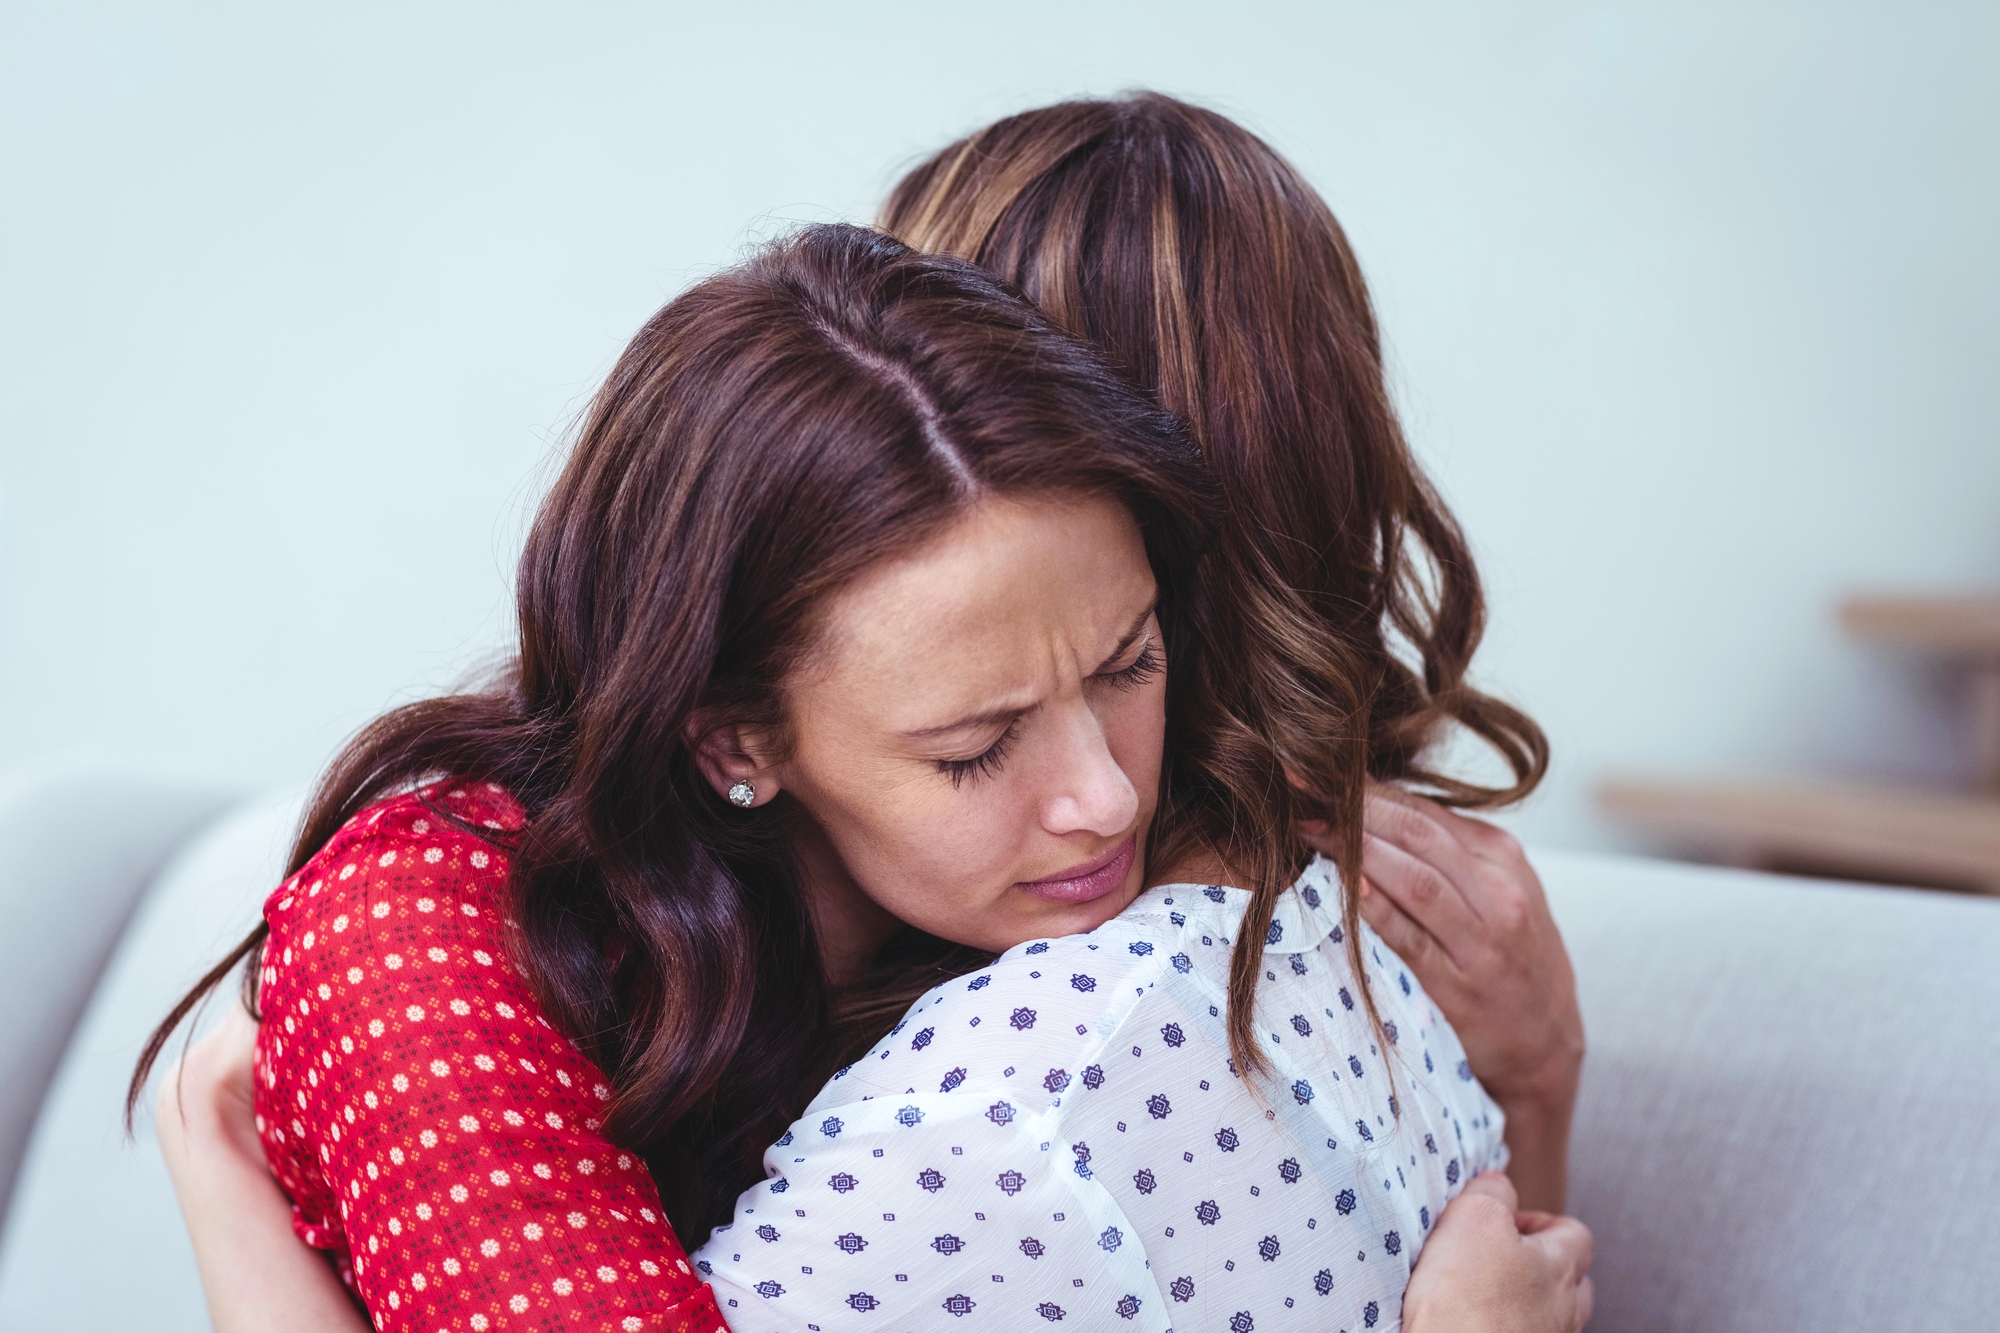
[0,767,2000,1333]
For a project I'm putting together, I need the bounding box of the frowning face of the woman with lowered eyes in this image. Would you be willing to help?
[770,498,1166,951]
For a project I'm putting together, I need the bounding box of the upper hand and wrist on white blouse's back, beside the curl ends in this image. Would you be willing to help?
[1304,785,1584,1213]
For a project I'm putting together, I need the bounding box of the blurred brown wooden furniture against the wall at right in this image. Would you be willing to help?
[1598,596,2000,895]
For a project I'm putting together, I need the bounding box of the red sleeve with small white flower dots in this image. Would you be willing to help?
[256,785,726,1333]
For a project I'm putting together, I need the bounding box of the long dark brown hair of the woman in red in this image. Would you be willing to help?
[132,226,1214,1243]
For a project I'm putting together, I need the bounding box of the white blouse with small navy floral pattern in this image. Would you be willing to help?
[696,859,1506,1333]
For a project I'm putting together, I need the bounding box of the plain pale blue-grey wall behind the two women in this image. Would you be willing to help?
[0,0,2000,843]
